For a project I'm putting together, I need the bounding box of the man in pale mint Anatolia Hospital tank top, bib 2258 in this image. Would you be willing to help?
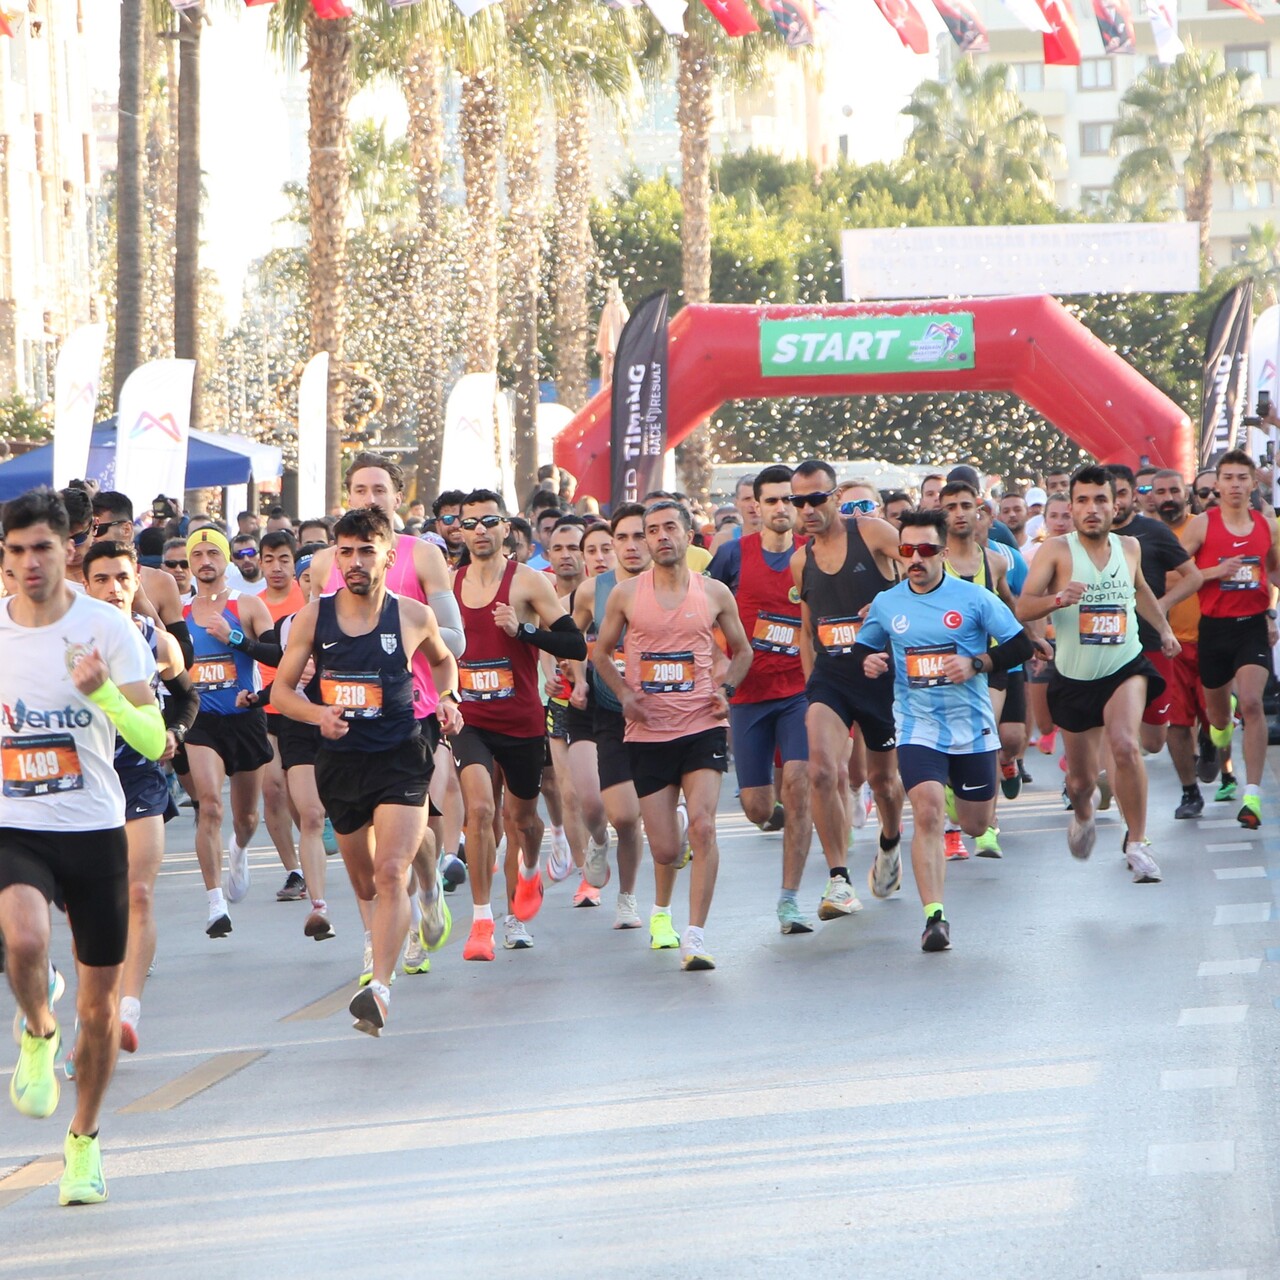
[1018,466,1178,884]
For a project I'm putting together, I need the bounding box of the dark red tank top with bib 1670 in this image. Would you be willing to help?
[453,561,547,737]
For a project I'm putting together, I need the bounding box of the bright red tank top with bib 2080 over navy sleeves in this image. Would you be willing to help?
[733,534,804,703]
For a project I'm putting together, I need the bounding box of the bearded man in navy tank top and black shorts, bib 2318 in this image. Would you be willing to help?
[271,508,460,1036]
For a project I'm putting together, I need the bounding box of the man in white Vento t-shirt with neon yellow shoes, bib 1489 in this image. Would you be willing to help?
[0,490,165,1204]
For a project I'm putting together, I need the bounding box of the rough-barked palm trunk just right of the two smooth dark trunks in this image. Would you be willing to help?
[307,13,352,508]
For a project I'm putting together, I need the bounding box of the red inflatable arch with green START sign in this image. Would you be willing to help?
[554,296,1196,502]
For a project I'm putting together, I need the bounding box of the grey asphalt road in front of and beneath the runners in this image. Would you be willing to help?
[0,751,1280,1280]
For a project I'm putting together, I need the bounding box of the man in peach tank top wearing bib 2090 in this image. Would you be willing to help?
[596,499,751,969]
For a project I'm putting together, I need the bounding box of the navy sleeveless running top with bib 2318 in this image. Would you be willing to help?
[308,591,417,751]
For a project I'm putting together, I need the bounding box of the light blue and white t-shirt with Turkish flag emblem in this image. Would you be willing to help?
[858,573,1023,755]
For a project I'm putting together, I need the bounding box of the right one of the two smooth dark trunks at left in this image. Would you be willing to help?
[173,4,204,429]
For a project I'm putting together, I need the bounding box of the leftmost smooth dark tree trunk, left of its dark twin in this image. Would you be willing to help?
[111,0,143,403]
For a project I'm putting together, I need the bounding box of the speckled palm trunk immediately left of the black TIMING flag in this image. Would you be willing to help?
[554,84,595,411]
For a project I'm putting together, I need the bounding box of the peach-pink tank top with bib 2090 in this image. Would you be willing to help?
[622,570,724,742]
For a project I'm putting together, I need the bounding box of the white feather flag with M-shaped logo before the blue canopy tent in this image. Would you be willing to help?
[115,360,196,511]
